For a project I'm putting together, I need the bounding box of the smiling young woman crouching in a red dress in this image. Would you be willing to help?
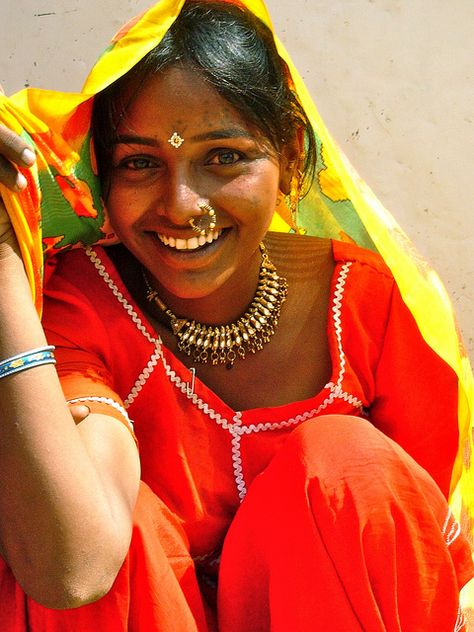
[0,2,473,632]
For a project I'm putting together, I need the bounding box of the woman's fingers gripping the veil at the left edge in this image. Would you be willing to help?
[0,85,36,191]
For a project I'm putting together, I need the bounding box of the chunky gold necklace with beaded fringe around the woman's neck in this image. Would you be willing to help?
[142,243,288,368]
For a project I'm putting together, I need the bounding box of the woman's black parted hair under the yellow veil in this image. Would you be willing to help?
[93,0,317,191]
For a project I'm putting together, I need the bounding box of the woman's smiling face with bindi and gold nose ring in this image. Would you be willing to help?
[108,67,289,298]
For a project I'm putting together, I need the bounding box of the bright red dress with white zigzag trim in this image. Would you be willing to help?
[0,242,473,632]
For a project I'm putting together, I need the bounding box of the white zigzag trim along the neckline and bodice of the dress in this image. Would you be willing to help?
[86,248,363,501]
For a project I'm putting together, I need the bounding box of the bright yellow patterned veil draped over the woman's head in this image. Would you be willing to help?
[0,0,474,534]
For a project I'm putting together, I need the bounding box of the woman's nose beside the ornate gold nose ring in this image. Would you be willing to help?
[164,168,203,226]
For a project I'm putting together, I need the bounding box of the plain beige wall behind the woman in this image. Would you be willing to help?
[0,0,474,358]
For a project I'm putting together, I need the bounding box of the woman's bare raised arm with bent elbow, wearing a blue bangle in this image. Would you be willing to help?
[0,211,139,608]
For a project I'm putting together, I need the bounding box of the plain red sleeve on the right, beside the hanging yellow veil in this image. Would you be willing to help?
[369,284,459,497]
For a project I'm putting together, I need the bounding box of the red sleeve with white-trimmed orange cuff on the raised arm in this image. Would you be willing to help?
[43,252,133,430]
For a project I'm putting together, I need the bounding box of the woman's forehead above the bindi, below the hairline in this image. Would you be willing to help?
[119,67,251,135]
